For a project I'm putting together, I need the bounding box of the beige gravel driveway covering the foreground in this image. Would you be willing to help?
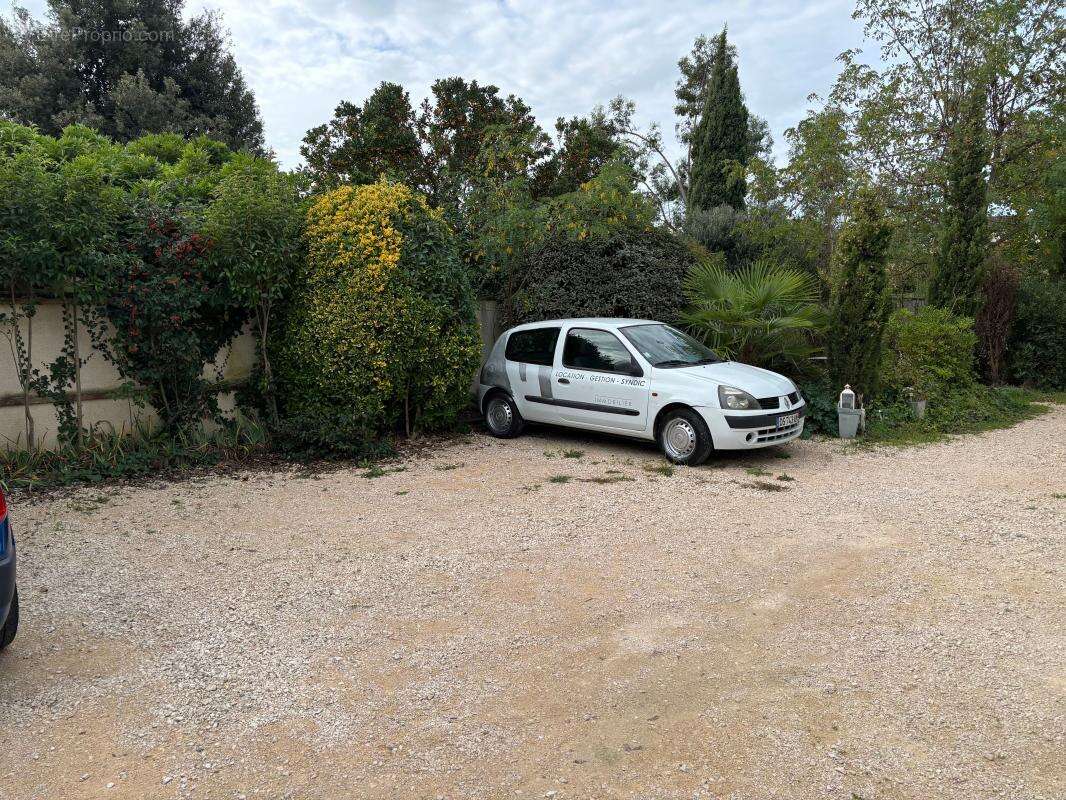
[0,406,1066,800]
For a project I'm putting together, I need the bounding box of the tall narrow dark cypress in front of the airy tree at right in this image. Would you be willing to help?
[930,84,988,317]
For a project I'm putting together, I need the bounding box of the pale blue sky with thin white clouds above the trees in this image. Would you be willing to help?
[16,0,861,166]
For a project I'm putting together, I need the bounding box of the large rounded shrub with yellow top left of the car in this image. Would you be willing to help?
[277,180,481,434]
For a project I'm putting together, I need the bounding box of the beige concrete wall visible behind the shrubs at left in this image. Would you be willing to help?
[0,301,256,449]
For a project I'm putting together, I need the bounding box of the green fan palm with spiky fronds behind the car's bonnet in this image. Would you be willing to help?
[681,256,828,372]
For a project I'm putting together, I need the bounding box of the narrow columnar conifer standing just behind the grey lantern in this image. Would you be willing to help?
[828,188,892,398]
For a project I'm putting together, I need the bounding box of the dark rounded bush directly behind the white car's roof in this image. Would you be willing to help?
[504,228,696,324]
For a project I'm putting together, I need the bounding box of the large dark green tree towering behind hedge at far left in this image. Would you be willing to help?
[0,0,263,150]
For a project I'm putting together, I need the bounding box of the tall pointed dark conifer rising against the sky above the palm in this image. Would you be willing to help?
[689,29,750,210]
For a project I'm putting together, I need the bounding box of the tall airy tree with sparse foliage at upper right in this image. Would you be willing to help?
[829,0,1066,234]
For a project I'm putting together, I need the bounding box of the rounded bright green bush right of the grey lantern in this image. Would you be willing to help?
[881,306,978,404]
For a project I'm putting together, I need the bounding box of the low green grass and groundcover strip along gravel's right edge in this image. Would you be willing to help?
[861,384,1051,447]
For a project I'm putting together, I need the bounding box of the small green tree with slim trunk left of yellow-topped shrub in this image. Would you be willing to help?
[204,155,303,422]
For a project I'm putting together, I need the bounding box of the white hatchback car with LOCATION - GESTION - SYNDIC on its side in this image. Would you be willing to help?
[478,319,807,465]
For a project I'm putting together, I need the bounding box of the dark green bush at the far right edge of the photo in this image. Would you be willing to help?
[1007,277,1066,389]
